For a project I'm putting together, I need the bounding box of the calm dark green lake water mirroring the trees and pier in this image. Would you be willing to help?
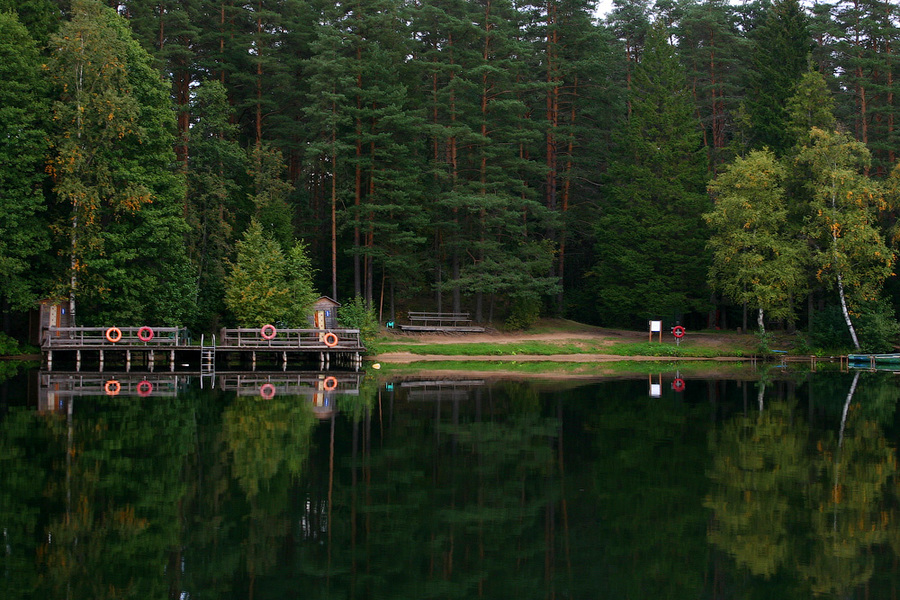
[0,368,900,600]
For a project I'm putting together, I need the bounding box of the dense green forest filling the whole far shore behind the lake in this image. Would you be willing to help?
[0,0,900,350]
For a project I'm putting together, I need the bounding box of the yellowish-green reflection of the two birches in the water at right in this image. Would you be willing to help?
[706,373,898,597]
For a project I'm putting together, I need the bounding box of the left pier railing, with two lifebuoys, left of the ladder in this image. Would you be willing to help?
[42,327,191,349]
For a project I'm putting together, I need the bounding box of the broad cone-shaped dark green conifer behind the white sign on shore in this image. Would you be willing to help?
[590,18,708,325]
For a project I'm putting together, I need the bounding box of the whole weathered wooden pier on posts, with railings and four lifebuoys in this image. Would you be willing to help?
[41,325,365,373]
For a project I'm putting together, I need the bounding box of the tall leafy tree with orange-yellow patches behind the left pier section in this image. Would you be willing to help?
[48,0,195,325]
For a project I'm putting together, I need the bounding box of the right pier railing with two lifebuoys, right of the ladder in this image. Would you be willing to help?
[218,328,363,351]
